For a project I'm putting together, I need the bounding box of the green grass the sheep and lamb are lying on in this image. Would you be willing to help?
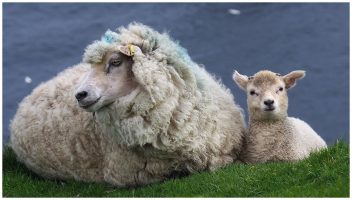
[3,142,349,197]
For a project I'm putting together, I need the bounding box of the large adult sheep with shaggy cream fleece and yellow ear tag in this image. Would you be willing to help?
[11,23,245,186]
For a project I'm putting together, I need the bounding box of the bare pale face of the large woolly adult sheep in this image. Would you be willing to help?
[75,51,137,112]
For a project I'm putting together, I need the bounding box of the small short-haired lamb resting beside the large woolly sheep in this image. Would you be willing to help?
[233,70,326,163]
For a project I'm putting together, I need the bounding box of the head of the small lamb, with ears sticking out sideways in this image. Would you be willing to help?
[233,70,305,120]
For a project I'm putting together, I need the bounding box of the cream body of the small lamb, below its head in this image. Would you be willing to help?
[241,117,326,163]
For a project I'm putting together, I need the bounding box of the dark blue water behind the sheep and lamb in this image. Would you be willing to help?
[3,3,349,144]
